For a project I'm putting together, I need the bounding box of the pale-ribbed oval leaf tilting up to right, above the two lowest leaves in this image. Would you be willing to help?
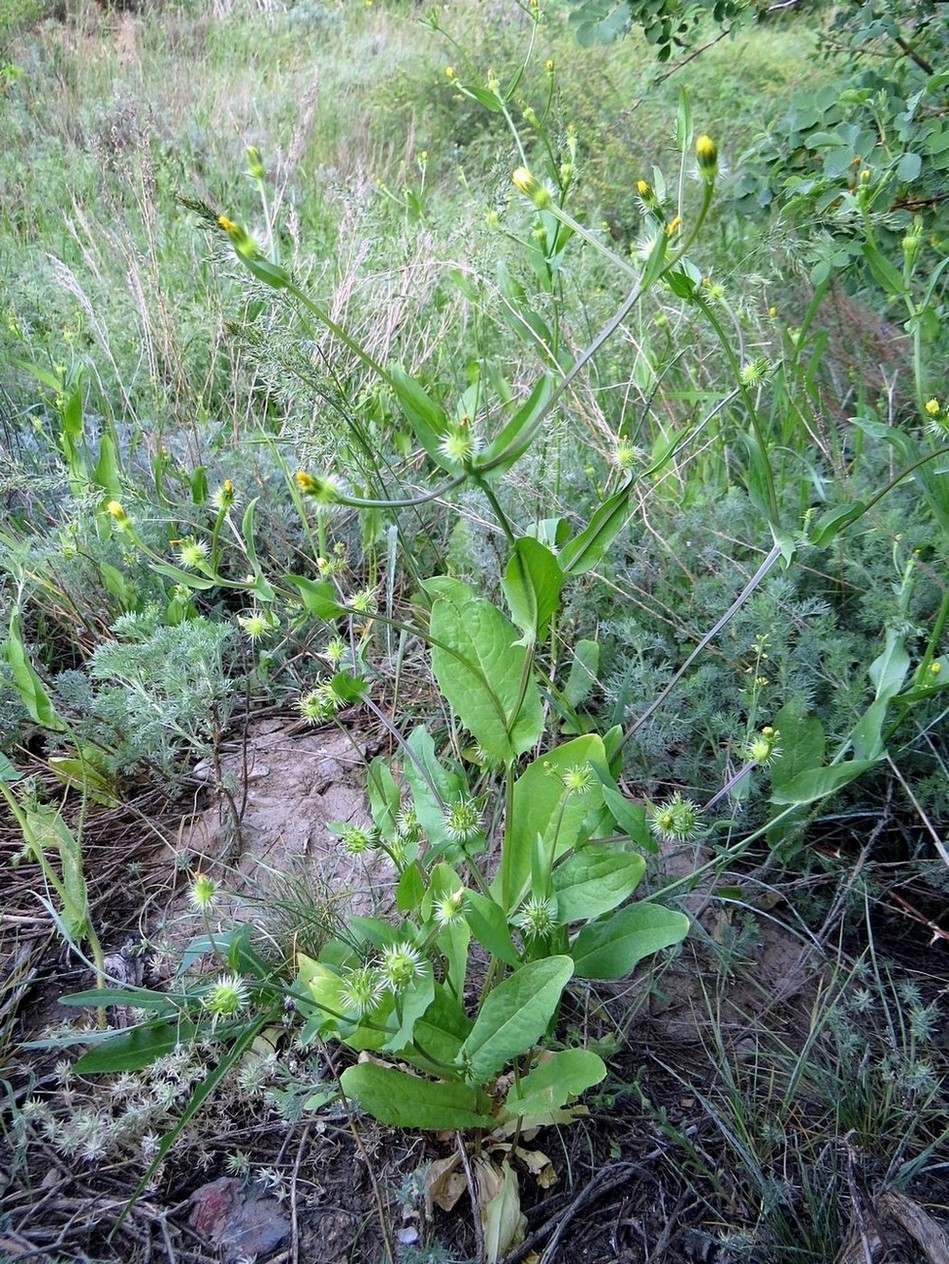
[457,957,574,1083]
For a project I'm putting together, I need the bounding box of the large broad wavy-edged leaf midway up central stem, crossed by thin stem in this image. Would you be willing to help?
[422,578,543,763]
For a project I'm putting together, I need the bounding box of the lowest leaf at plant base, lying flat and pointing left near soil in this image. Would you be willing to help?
[340,1062,493,1131]
